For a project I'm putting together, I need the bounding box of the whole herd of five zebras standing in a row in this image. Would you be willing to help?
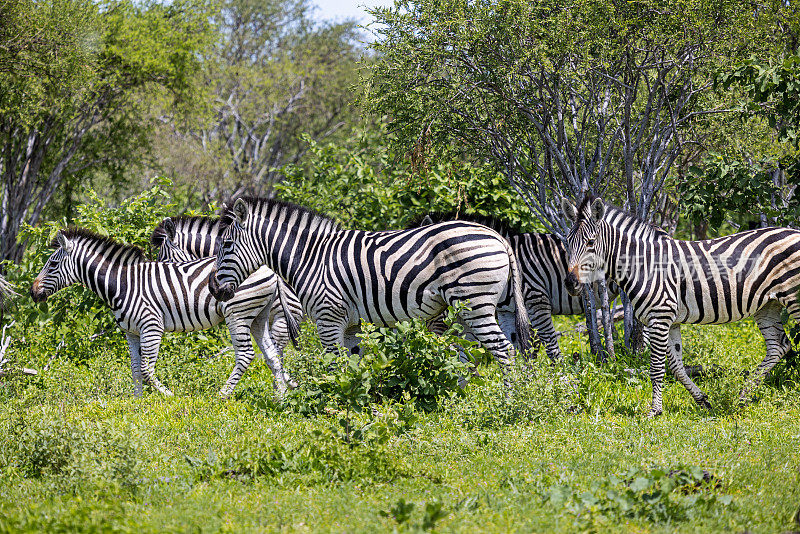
[31,196,800,416]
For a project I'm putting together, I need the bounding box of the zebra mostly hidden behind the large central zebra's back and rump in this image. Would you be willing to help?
[409,213,616,360]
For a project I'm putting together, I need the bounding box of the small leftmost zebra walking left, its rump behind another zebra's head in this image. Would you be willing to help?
[31,228,292,397]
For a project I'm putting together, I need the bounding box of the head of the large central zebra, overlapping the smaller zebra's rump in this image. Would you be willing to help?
[208,198,261,302]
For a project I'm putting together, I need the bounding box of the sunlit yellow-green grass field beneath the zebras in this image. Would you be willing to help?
[0,320,800,532]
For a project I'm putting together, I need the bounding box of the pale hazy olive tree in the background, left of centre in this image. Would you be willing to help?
[154,0,362,202]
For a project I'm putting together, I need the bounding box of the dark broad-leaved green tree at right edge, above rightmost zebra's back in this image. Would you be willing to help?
[679,6,800,237]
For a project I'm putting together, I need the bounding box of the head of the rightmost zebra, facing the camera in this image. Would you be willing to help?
[561,196,607,295]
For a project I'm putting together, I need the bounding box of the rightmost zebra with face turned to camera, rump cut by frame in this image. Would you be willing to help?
[562,197,800,417]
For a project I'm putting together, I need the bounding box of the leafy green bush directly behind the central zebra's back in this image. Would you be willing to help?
[275,128,541,231]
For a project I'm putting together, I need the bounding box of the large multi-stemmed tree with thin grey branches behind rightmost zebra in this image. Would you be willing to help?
[367,0,776,360]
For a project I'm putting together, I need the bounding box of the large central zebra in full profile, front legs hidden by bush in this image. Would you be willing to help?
[209,198,530,384]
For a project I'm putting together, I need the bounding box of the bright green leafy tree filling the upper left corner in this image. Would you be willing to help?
[0,0,211,260]
